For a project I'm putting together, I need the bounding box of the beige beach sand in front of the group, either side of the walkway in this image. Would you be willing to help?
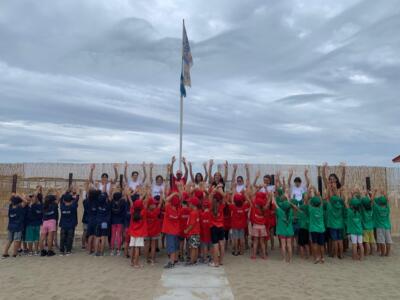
[0,239,400,300]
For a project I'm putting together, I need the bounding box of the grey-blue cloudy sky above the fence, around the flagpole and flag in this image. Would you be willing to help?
[0,0,400,165]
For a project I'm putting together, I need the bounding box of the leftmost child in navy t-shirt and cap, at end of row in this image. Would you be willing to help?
[3,195,27,258]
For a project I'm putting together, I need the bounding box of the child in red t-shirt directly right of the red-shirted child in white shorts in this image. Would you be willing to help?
[144,198,161,265]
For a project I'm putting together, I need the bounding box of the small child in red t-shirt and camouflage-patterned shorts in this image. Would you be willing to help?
[184,198,200,265]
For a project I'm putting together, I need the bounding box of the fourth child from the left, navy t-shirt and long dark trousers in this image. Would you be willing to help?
[59,193,79,256]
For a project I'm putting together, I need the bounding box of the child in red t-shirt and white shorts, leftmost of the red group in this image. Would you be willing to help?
[128,199,148,268]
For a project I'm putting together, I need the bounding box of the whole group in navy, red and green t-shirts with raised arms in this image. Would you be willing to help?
[3,157,392,268]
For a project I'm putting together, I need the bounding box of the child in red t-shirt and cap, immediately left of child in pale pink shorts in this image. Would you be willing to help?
[229,193,249,256]
